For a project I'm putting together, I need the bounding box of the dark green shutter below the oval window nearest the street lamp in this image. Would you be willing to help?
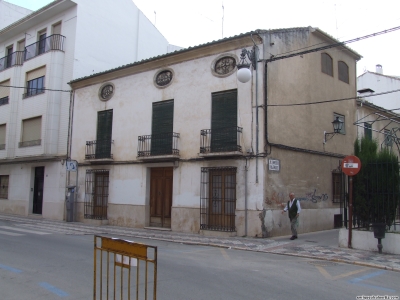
[211,90,237,152]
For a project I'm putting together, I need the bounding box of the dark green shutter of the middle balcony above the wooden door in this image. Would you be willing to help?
[151,100,174,155]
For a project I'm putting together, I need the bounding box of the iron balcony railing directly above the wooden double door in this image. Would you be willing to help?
[138,132,179,157]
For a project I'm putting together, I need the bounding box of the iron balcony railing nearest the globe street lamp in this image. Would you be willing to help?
[200,127,243,154]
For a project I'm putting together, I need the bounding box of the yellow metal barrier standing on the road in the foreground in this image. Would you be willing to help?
[93,235,157,300]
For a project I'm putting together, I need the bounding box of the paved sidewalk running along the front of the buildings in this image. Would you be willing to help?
[0,214,400,272]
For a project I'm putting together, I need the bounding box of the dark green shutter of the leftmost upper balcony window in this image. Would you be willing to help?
[96,109,113,158]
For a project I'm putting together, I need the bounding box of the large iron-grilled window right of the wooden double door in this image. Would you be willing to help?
[200,167,237,231]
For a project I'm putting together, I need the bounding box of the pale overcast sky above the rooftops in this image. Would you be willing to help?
[5,0,400,76]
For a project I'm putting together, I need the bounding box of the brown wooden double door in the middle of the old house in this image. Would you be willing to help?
[150,167,173,228]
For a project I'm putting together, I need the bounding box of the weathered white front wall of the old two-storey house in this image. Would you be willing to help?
[71,48,264,236]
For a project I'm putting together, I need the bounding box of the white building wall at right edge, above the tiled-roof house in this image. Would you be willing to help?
[357,71,400,113]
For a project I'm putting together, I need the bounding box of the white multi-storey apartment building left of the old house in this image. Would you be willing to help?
[0,0,177,220]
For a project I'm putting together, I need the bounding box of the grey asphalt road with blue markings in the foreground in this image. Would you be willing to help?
[0,221,400,300]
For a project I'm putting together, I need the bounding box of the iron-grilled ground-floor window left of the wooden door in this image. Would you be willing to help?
[84,169,109,220]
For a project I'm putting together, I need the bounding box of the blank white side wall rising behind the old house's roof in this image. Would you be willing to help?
[73,0,175,78]
